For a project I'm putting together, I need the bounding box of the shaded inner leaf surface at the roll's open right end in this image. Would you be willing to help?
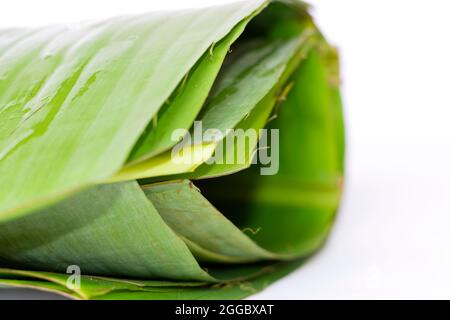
[196,46,342,256]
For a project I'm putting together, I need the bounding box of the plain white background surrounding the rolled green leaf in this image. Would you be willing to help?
[0,0,450,299]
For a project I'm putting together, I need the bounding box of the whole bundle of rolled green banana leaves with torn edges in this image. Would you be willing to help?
[0,0,344,299]
